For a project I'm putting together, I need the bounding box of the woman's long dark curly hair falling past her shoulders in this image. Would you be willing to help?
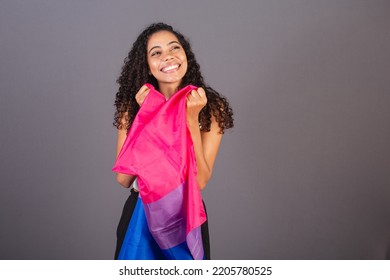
[113,23,233,133]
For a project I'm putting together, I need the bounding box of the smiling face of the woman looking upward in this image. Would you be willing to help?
[146,31,188,87]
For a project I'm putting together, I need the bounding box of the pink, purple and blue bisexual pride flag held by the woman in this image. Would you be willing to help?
[112,84,206,260]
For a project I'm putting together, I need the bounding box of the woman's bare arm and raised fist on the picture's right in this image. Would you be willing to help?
[187,88,222,190]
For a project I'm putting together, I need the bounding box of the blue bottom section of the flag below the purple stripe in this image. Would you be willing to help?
[118,197,193,260]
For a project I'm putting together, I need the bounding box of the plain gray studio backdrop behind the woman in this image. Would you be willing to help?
[0,0,390,259]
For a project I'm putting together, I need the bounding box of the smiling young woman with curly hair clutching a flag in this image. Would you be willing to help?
[114,23,233,259]
